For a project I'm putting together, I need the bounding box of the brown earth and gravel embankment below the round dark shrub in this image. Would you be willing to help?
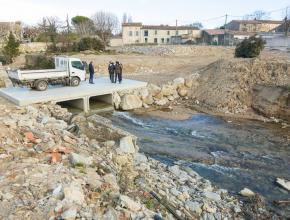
[191,59,290,120]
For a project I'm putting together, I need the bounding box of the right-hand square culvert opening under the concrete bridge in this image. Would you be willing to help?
[89,94,114,112]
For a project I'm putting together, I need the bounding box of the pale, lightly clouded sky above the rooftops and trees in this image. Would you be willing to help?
[0,0,290,28]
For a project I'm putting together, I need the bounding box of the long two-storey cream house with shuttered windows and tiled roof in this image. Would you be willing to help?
[122,23,201,44]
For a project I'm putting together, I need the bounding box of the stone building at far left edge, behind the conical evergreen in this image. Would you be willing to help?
[0,21,22,43]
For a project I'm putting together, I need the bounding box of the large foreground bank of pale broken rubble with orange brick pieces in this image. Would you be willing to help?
[0,101,242,219]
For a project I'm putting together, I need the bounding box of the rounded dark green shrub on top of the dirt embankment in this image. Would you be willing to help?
[235,37,266,58]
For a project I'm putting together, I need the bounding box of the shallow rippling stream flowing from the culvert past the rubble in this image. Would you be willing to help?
[106,112,290,216]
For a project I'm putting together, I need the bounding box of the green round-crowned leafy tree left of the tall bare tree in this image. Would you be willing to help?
[71,15,94,36]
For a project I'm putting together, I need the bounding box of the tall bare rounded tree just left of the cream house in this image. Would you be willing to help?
[92,11,119,44]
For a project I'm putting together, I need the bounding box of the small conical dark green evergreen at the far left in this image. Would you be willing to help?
[3,32,20,63]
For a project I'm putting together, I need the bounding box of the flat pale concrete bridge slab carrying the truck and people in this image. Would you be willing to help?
[0,77,147,112]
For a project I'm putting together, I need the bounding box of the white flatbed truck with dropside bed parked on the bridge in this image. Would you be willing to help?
[7,56,86,91]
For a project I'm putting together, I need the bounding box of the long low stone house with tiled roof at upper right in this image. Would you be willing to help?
[226,20,283,33]
